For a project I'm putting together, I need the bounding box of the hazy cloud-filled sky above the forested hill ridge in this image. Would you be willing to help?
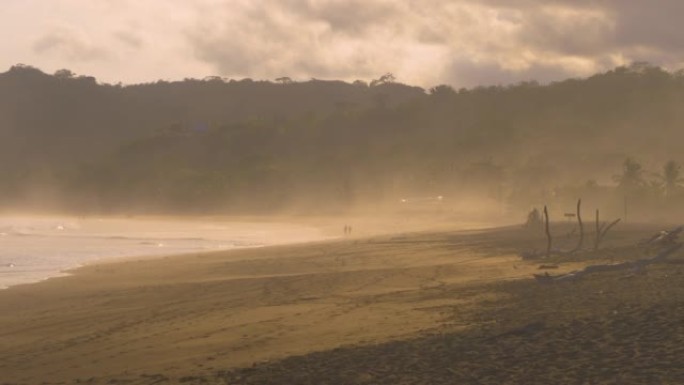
[0,0,684,88]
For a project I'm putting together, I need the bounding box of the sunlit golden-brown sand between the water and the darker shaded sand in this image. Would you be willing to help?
[0,220,664,385]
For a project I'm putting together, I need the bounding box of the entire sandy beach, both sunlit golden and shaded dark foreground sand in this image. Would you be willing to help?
[0,220,684,385]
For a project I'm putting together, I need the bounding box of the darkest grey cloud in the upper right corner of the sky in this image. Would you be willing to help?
[478,0,684,65]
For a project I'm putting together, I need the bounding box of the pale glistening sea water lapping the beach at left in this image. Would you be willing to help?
[0,216,324,289]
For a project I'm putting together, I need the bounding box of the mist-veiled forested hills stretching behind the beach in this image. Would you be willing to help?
[0,63,684,218]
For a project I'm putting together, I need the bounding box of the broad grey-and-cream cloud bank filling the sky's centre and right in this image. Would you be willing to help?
[187,0,684,86]
